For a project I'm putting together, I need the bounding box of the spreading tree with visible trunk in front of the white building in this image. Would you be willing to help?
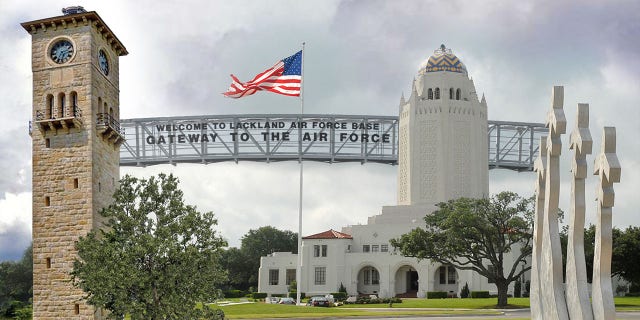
[391,191,533,307]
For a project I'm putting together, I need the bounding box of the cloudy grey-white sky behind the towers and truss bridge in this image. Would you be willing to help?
[0,0,640,260]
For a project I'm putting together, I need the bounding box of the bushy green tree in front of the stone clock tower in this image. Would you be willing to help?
[72,174,226,320]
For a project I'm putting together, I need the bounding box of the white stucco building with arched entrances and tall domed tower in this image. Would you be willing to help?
[258,45,524,297]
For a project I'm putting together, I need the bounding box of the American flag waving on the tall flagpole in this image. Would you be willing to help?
[223,50,302,99]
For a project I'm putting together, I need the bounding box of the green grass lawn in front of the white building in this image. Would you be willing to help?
[220,297,640,319]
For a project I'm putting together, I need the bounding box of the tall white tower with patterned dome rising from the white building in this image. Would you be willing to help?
[369,45,489,224]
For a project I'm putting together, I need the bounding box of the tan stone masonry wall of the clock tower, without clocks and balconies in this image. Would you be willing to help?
[32,18,119,319]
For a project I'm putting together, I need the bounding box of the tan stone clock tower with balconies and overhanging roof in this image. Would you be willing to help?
[22,7,127,319]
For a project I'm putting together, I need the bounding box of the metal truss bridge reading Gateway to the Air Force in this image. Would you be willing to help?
[120,114,546,171]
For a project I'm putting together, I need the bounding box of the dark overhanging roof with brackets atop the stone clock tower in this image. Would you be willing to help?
[20,10,129,56]
